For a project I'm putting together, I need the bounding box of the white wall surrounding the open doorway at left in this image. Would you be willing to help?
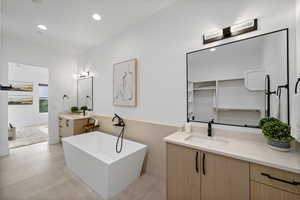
[0,35,77,155]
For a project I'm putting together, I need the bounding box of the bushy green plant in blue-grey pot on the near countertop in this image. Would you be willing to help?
[259,117,294,151]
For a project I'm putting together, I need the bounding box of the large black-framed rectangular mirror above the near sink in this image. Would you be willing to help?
[187,29,289,127]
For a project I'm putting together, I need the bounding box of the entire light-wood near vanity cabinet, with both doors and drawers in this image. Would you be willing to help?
[167,143,300,200]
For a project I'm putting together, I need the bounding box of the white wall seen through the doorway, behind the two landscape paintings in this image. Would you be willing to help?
[8,63,48,127]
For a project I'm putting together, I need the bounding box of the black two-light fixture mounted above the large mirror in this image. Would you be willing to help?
[203,19,257,44]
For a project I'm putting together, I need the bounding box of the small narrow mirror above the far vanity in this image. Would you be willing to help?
[77,77,93,110]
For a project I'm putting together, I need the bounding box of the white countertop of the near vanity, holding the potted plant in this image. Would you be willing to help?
[164,131,300,174]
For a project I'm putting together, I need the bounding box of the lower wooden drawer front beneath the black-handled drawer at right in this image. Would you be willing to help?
[251,181,300,200]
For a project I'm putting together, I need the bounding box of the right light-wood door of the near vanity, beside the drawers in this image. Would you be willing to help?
[201,152,250,200]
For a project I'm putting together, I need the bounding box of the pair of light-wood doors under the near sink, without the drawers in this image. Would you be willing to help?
[167,144,249,200]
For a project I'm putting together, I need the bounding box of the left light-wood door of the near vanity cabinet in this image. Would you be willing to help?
[167,144,201,200]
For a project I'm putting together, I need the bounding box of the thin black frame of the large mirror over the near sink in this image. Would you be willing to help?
[185,28,290,128]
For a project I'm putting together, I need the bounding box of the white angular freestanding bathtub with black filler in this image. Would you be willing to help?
[62,132,146,199]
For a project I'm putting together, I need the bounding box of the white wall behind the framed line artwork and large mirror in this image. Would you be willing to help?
[78,0,295,124]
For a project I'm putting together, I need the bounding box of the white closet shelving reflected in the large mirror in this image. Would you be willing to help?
[192,77,264,125]
